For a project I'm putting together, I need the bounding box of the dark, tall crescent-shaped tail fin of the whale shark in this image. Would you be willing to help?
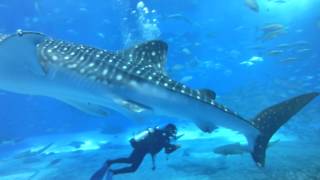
[251,93,319,167]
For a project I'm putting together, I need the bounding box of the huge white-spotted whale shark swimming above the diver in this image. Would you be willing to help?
[0,30,319,167]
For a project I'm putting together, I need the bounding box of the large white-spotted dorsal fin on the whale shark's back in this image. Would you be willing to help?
[119,40,168,73]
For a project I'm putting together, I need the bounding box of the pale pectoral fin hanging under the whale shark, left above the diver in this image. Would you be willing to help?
[59,99,109,118]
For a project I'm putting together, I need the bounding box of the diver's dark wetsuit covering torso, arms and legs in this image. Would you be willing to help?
[106,129,177,175]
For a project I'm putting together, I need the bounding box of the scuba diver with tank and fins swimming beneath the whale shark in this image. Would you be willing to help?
[91,124,182,180]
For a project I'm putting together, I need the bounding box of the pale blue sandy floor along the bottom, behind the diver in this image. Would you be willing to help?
[0,136,320,180]
